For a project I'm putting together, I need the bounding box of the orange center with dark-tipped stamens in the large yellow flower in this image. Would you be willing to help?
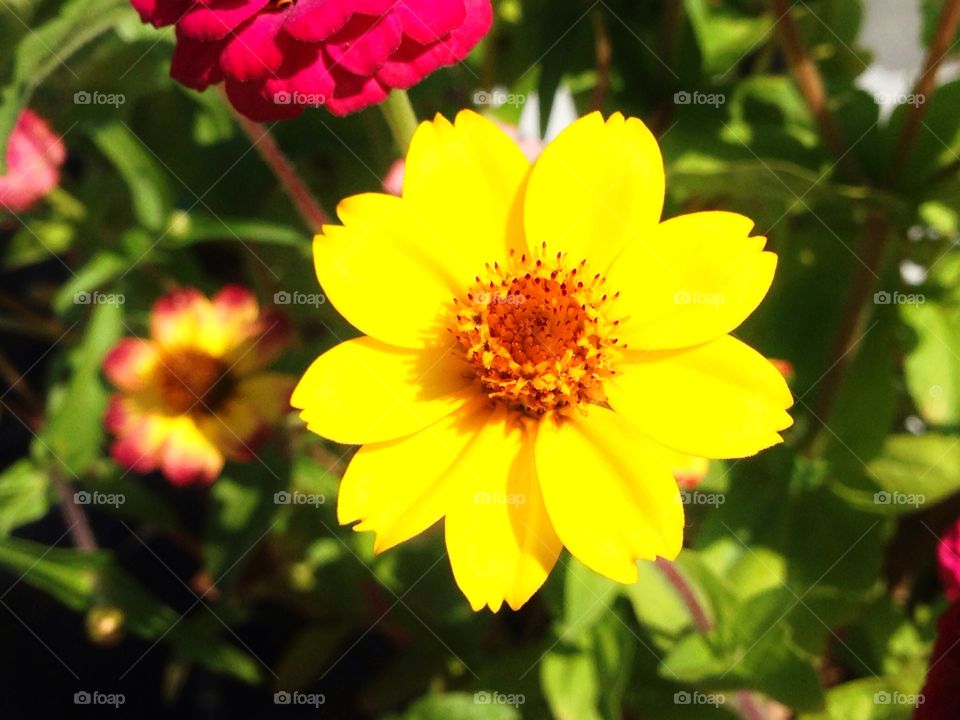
[452,243,626,418]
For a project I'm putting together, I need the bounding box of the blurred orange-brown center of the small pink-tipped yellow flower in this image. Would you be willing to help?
[157,350,234,414]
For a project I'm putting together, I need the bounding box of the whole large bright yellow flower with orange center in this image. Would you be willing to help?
[292,111,792,610]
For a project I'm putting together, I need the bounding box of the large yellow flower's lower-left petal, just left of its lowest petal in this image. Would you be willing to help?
[337,398,491,552]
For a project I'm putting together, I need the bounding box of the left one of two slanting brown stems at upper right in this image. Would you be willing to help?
[770,0,860,177]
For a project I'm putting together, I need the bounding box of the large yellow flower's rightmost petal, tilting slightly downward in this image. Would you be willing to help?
[605,336,793,458]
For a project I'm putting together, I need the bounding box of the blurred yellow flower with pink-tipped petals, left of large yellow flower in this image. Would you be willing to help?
[103,285,293,485]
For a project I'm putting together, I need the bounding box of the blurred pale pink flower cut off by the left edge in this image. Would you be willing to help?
[0,110,67,213]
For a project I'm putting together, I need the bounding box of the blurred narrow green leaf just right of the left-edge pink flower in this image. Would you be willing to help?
[91,120,173,230]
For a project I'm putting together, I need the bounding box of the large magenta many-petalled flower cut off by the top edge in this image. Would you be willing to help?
[131,0,493,121]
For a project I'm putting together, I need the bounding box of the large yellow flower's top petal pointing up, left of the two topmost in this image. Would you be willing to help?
[403,110,530,268]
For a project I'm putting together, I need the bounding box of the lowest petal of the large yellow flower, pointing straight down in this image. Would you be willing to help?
[444,410,562,612]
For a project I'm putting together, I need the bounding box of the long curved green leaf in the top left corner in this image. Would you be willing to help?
[0,0,131,175]
